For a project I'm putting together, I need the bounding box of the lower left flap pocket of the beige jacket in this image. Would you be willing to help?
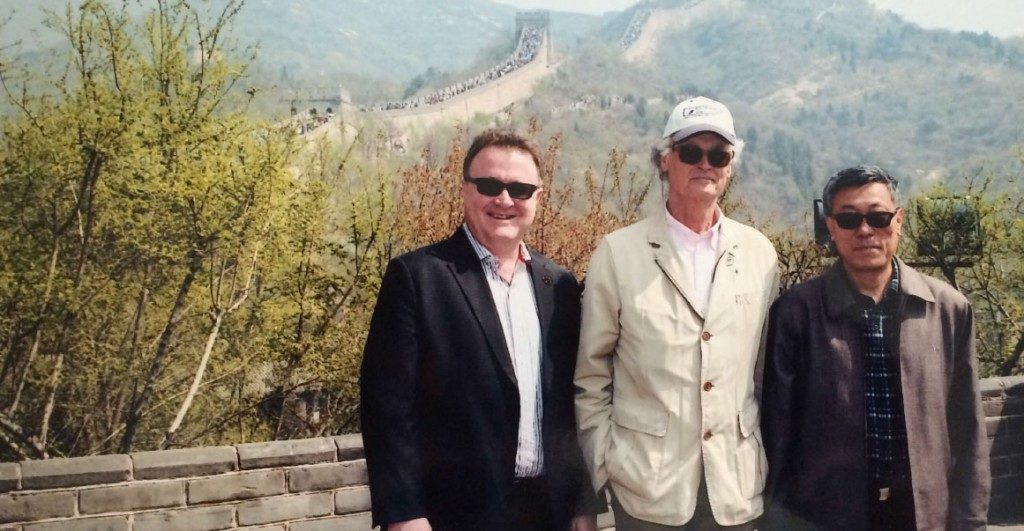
[605,403,669,499]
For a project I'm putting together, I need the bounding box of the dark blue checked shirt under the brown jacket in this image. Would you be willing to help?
[860,261,908,484]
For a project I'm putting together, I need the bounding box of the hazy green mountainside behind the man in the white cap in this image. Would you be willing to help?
[520,0,1024,215]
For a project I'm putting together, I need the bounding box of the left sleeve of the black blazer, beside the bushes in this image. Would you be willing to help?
[359,259,426,527]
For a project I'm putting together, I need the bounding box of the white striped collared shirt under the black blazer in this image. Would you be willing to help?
[462,224,544,478]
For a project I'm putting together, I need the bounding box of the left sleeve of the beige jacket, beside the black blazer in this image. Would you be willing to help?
[574,238,621,490]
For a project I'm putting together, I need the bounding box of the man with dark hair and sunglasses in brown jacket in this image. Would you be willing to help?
[761,166,990,530]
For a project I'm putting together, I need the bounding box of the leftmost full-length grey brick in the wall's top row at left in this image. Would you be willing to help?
[22,455,131,489]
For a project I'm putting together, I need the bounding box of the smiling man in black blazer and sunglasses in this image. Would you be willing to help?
[359,130,596,531]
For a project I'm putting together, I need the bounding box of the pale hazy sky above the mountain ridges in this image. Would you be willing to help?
[497,0,1024,37]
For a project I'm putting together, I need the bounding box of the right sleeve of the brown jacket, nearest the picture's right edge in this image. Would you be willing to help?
[946,304,991,530]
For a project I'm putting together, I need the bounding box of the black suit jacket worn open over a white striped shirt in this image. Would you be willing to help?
[359,228,595,530]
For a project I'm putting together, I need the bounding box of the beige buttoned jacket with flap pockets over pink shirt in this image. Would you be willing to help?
[575,212,778,526]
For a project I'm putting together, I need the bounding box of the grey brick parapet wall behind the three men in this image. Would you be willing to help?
[0,377,1024,531]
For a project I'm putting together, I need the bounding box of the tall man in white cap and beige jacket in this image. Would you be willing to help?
[575,97,778,531]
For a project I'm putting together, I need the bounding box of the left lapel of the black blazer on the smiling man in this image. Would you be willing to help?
[449,226,518,386]
